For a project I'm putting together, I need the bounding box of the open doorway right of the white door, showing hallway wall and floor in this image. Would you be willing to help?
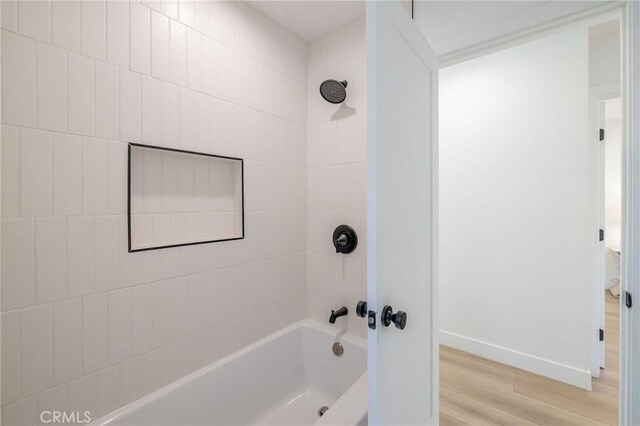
[439,15,620,424]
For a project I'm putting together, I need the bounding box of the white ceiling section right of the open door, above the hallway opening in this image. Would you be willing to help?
[415,0,613,56]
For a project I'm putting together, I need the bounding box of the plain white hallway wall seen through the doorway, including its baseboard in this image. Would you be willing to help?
[440,30,595,387]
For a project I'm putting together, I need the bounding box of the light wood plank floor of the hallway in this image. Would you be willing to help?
[440,292,620,426]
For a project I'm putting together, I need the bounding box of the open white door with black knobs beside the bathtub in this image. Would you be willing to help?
[367,1,438,425]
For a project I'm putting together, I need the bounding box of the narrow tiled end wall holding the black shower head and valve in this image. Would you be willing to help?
[307,17,367,337]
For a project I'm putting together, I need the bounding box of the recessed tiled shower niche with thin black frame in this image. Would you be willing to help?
[127,143,244,253]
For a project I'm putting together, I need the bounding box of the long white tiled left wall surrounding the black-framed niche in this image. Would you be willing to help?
[1,0,310,425]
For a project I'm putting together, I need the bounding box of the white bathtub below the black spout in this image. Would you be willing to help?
[91,319,367,426]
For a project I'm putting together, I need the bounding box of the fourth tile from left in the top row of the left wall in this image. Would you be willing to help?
[80,0,107,61]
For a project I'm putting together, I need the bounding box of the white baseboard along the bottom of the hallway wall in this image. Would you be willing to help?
[440,330,591,390]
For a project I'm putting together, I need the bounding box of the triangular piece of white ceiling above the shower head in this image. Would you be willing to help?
[248,0,365,41]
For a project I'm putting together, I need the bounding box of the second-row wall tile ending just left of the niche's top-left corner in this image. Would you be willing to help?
[95,62,120,139]
